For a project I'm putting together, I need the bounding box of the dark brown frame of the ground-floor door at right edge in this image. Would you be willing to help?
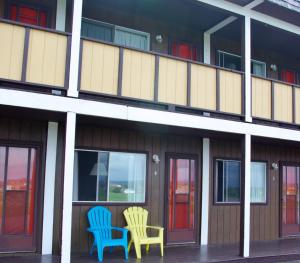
[278,161,300,239]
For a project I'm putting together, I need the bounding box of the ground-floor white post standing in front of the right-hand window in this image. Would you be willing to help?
[240,134,251,257]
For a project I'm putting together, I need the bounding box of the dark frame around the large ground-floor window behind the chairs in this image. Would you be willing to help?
[72,146,149,206]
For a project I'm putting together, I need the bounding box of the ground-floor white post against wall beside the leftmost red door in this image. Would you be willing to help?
[42,122,58,255]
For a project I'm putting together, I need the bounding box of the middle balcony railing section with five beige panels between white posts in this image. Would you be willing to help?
[80,39,244,116]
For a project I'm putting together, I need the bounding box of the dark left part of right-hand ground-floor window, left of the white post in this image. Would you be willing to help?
[216,160,241,203]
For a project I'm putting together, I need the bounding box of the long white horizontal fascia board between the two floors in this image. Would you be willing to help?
[0,89,300,142]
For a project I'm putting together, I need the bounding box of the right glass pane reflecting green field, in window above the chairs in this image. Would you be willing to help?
[108,152,146,202]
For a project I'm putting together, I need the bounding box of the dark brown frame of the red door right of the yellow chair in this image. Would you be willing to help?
[164,152,201,247]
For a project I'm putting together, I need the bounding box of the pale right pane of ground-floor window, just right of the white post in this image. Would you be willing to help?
[251,162,267,203]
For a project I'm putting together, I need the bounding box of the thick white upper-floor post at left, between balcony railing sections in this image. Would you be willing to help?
[68,0,83,97]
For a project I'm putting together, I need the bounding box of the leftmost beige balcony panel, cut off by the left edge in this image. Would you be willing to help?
[0,23,25,80]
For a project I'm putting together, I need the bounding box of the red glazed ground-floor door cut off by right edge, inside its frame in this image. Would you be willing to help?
[281,166,300,236]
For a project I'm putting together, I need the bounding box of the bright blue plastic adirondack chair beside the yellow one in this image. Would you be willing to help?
[87,206,128,261]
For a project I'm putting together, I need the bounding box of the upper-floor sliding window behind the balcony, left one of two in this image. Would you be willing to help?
[81,18,150,50]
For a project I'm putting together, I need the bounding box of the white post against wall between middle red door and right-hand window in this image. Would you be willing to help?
[201,138,210,245]
